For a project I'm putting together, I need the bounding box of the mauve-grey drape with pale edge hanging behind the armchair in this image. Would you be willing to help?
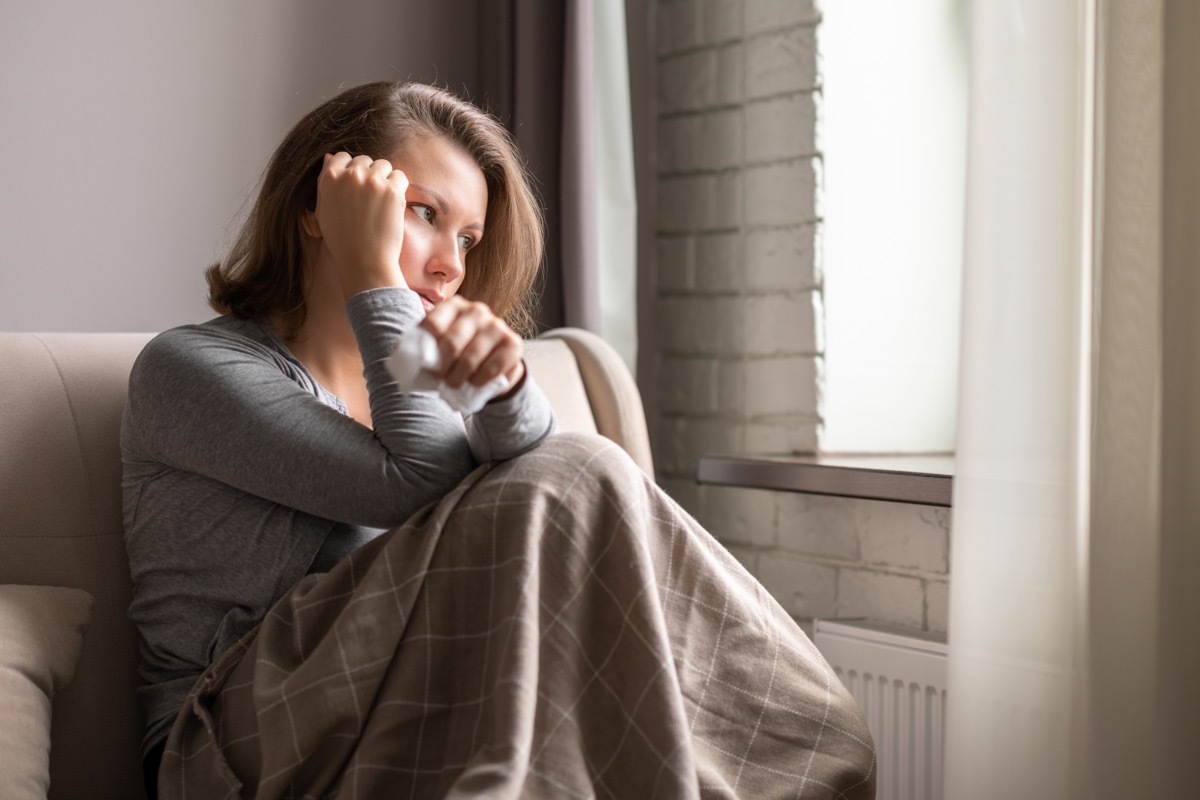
[479,0,638,368]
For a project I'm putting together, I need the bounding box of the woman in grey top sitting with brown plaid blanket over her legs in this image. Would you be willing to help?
[121,83,874,798]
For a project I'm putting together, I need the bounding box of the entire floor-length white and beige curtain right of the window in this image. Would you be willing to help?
[944,0,1200,800]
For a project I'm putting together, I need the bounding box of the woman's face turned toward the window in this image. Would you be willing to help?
[388,137,487,311]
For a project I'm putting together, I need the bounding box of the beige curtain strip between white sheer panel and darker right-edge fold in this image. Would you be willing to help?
[1086,0,1163,798]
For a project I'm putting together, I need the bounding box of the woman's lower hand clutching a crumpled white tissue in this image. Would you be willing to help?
[421,296,524,389]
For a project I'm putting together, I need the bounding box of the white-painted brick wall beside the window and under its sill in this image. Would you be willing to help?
[655,0,949,631]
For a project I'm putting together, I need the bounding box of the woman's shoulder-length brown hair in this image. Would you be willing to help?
[205,82,544,336]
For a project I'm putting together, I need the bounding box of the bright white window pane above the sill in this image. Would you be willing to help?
[817,0,968,452]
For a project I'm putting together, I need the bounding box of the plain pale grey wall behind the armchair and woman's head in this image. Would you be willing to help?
[0,0,479,331]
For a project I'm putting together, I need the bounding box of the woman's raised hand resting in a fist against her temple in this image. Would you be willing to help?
[305,152,408,299]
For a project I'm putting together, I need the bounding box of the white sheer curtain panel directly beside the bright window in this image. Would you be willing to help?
[946,0,1091,799]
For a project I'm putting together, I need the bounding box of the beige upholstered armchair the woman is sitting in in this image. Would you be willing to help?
[0,329,653,800]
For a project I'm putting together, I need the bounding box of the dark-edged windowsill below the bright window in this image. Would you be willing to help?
[696,453,954,507]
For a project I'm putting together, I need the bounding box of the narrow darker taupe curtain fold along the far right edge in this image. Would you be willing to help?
[1142,0,1200,798]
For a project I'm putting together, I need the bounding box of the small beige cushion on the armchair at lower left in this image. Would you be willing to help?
[0,585,92,800]
